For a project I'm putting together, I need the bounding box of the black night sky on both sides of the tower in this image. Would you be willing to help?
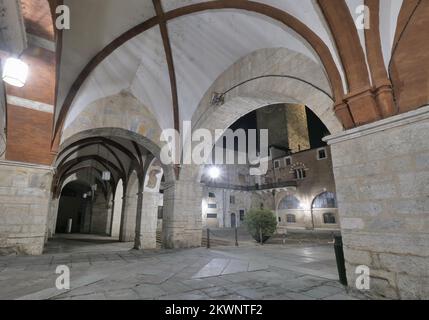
[231,106,329,149]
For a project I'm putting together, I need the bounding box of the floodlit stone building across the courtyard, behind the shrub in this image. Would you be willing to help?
[202,147,340,232]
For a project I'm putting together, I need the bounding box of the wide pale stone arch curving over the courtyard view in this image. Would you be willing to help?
[180,48,344,181]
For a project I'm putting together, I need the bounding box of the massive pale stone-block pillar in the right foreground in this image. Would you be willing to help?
[327,107,429,299]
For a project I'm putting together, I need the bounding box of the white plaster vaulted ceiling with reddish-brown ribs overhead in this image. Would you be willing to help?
[56,0,402,144]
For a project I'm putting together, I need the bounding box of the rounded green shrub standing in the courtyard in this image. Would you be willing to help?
[244,209,277,242]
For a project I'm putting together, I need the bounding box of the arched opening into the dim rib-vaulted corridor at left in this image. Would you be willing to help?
[48,129,169,254]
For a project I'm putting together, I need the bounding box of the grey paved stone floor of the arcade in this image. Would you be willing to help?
[0,238,362,300]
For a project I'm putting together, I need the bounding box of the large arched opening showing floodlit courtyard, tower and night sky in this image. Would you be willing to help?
[200,104,340,275]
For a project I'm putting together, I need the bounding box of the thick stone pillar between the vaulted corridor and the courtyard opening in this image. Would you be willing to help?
[163,180,203,248]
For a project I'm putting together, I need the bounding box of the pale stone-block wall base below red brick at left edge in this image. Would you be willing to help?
[0,161,52,255]
